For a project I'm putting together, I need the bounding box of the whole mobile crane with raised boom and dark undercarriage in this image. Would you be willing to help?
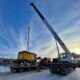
[30,3,80,75]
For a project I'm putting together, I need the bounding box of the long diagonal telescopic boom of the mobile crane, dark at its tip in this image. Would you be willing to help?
[30,3,71,53]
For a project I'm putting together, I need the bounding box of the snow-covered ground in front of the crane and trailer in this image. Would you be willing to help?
[0,69,80,80]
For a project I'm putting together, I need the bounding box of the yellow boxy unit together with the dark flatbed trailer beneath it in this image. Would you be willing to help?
[10,51,37,72]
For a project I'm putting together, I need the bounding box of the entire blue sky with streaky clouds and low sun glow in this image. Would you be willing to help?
[0,0,80,58]
